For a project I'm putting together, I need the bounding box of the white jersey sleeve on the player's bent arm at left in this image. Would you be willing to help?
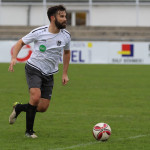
[22,31,37,44]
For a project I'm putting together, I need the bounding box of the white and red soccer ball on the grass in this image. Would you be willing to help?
[93,123,111,141]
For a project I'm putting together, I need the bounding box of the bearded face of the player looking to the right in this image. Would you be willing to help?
[55,11,67,29]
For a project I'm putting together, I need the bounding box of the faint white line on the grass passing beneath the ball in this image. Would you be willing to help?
[48,134,150,150]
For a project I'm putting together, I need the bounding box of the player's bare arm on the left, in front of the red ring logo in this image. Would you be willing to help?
[8,39,25,72]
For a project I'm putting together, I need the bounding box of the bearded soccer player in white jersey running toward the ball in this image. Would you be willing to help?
[8,5,71,138]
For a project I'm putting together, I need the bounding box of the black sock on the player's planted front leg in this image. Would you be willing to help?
[26,104,37,132]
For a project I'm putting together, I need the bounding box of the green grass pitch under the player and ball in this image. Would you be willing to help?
[0,64,150,150]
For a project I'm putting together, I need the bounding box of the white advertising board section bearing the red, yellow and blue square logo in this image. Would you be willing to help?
[108,42,150,64]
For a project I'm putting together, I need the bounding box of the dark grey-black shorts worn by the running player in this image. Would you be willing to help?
[25,64,54,100]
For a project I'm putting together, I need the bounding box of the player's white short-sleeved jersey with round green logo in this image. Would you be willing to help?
[22,25,71,75]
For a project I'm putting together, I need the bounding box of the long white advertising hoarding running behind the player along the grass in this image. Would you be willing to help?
[0,41,150,64]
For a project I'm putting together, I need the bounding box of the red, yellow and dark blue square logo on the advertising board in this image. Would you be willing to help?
[118,44,134,57]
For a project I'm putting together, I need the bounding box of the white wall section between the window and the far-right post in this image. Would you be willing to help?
[92,6,136,26]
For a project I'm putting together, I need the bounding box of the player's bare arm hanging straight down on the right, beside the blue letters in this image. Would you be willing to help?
[62,50,70,85]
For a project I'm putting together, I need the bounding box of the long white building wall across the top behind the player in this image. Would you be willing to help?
[0,4,150,26]
